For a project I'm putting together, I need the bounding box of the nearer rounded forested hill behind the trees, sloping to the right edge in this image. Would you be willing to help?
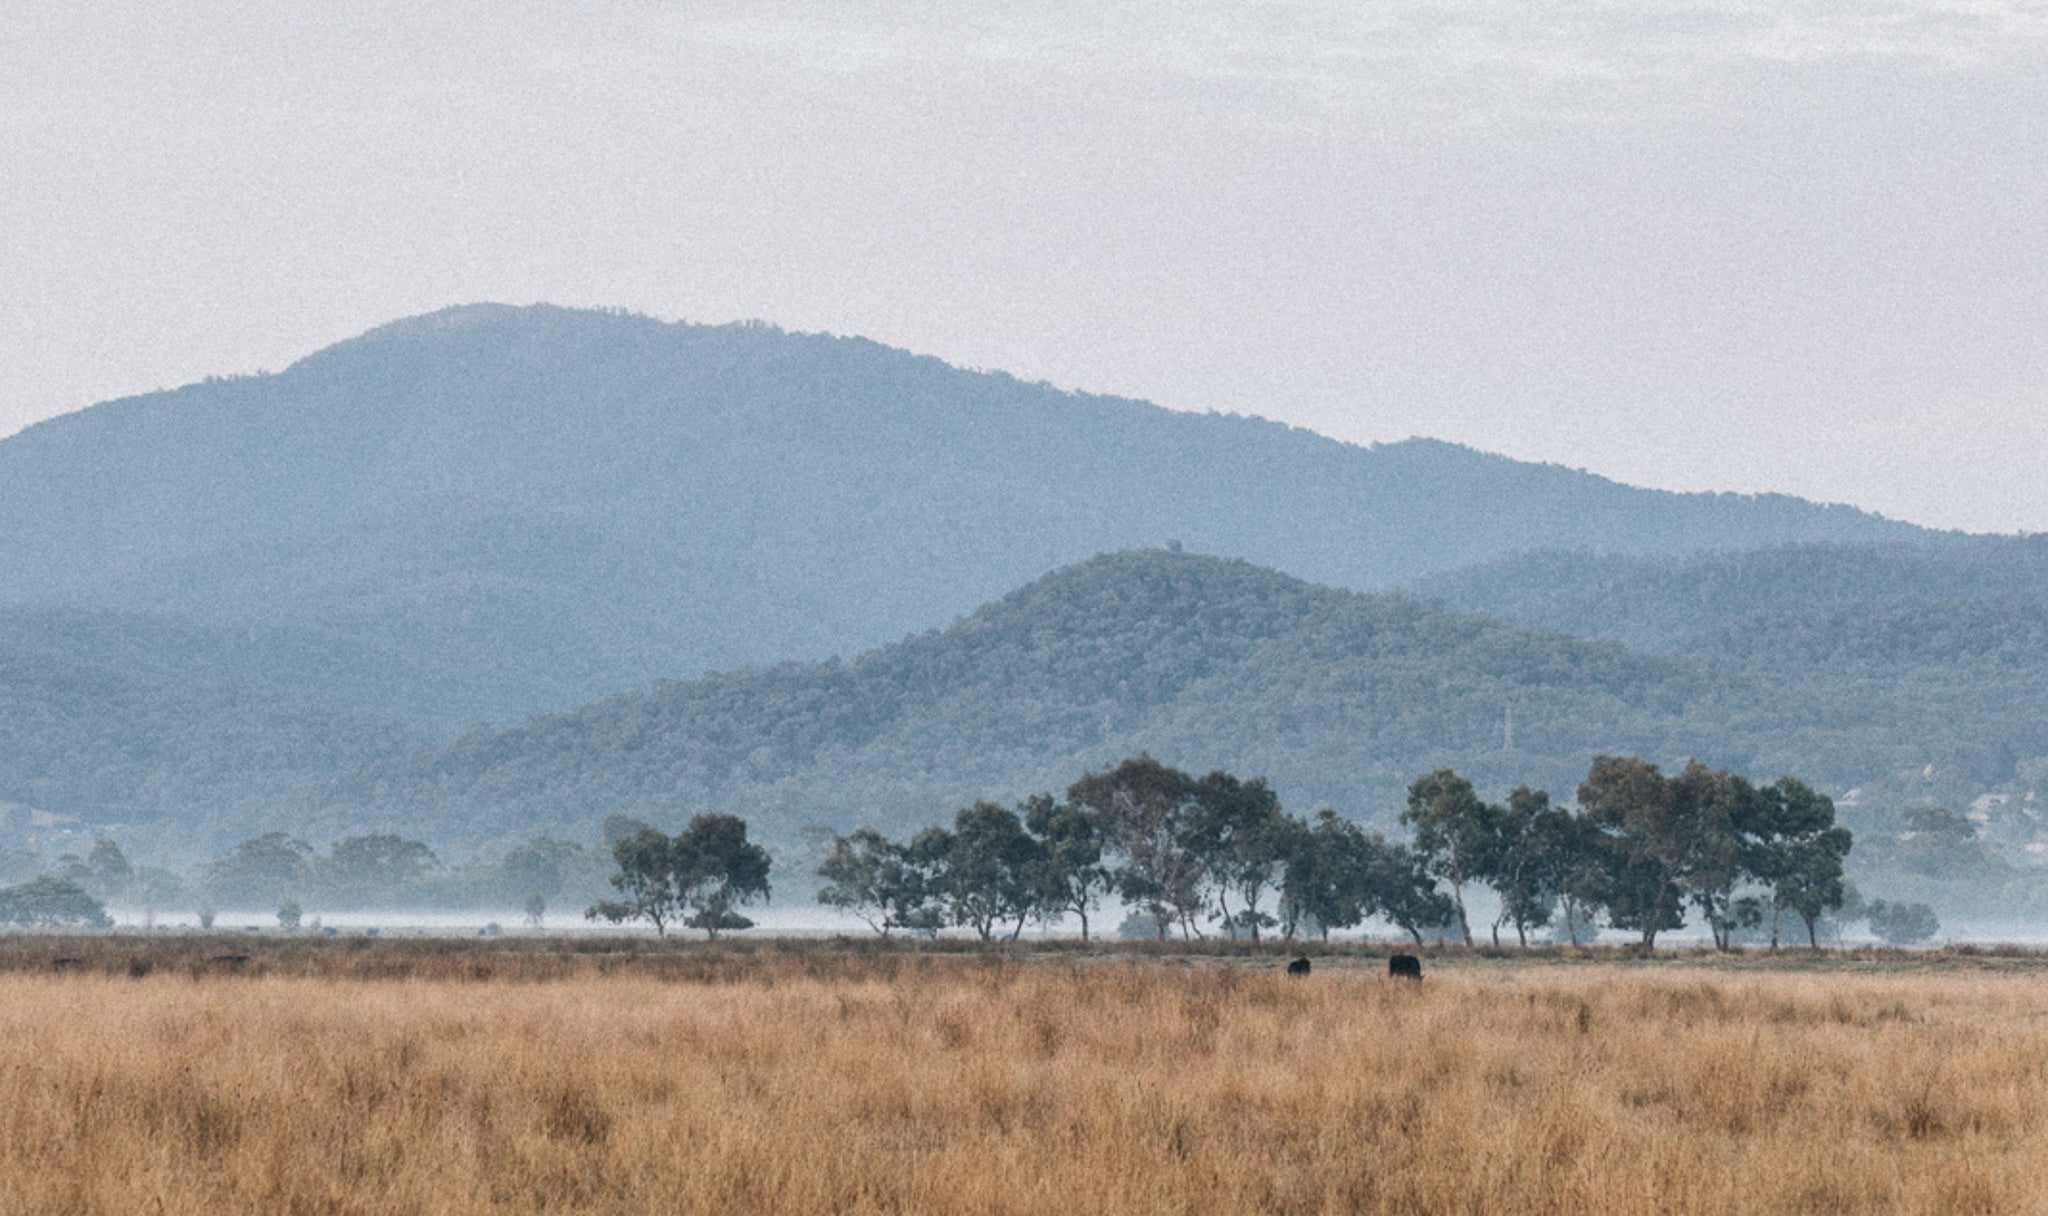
[322,551,2048,845]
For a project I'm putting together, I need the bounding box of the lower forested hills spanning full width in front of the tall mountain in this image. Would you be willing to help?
[19,549,2048,880]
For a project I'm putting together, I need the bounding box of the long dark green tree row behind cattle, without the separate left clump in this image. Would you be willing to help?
[815,755,1851,950]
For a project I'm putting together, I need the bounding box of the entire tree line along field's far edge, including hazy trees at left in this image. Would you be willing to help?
[0,755,1875,948]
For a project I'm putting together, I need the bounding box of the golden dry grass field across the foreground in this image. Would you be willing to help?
[0,940,2048,1216]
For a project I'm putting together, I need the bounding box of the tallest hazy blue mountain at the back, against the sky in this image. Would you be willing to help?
[0,305,1929,728]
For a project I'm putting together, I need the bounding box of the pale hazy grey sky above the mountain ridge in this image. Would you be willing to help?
[0,0,2048,530]
